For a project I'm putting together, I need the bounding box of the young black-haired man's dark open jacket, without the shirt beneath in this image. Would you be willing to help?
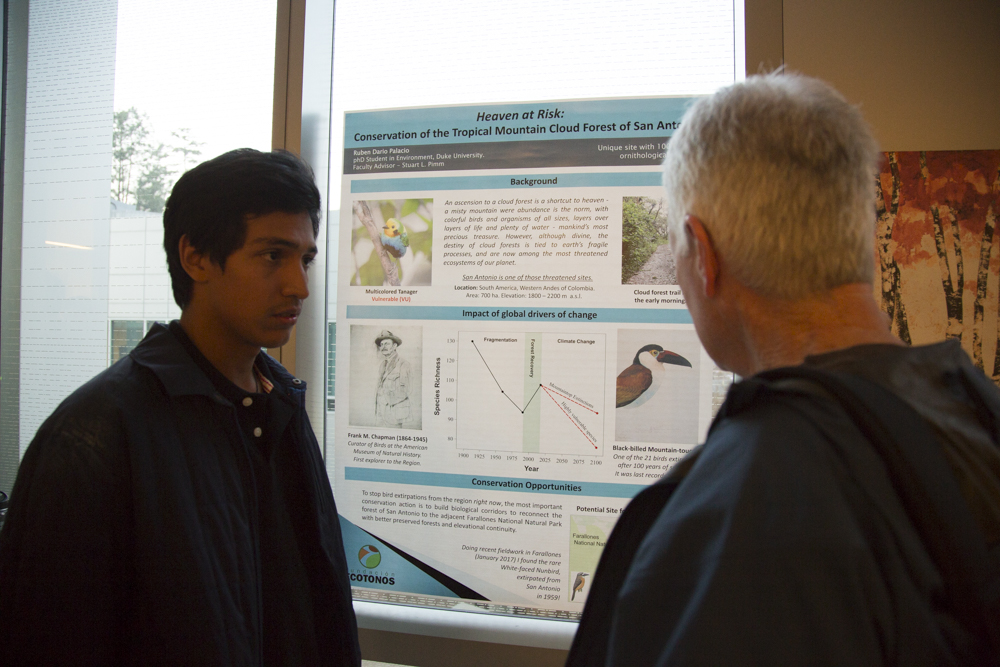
[0,326,361,665]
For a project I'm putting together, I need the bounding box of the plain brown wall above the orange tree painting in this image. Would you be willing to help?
[784,0,1000,151]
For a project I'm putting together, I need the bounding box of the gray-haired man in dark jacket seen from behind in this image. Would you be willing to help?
[567,74,1000,665]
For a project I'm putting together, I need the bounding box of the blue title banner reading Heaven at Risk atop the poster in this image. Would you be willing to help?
[344,97,691,149]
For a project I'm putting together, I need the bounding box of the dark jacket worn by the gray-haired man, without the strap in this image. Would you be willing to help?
[566,340,1000,667]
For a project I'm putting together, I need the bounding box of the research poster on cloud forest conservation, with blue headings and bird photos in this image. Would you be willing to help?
[335,98,714,618]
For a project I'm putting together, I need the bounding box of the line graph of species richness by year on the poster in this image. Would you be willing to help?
[456,332,606,455]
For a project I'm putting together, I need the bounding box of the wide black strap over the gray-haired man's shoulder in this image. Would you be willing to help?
[745,366,1000,664]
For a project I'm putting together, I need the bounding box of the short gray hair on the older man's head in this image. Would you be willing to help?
[663,74,880,298]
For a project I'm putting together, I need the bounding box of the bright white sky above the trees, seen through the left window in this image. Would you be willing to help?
[115,0,277,183]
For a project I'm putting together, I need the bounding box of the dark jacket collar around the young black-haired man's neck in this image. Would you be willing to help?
[129,324,306,403]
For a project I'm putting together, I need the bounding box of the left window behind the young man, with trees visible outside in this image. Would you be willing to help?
[0,0,277,480]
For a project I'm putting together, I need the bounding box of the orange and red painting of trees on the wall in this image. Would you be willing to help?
[875,150,1000,384]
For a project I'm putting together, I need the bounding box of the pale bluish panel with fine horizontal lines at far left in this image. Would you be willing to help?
[20,0,117,454]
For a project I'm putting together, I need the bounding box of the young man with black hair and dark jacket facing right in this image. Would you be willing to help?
[0,149,361,665]
